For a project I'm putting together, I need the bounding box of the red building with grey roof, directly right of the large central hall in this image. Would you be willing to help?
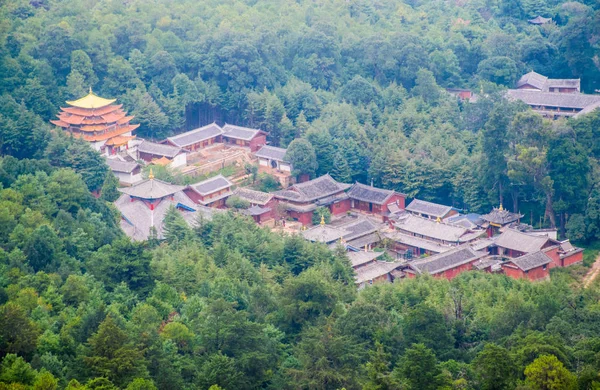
[348,183,406,221]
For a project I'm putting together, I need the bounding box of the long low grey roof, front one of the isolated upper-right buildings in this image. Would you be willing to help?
[507,89,600,110]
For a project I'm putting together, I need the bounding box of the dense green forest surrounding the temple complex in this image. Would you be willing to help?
[0,0,600,390]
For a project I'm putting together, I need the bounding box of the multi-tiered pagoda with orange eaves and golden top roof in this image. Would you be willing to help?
[50,88,140,154]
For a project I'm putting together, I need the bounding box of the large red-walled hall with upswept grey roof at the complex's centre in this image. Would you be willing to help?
[274,175,350,225]
